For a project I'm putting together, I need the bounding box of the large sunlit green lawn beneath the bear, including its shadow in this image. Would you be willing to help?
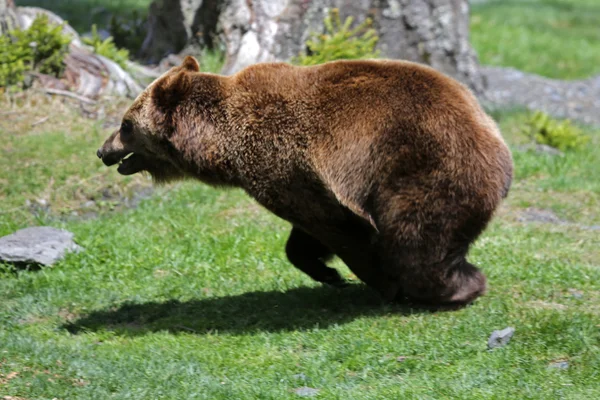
[0,95,600,399]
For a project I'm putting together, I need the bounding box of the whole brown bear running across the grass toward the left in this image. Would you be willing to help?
[97,57,513,305]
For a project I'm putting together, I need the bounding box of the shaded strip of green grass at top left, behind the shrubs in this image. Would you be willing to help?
[16,0,152,33]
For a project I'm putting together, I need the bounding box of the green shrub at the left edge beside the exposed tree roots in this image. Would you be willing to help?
[0,15,71,87]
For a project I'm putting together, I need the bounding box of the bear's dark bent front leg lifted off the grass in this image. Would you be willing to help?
[285,227,348,287]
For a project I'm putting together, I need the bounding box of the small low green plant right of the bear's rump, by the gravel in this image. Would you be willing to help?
[523,112,590,151]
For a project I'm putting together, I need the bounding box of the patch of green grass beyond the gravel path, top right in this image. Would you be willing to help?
[471,0,600,79]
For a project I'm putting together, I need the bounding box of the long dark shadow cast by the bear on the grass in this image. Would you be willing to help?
[63,284,430,336]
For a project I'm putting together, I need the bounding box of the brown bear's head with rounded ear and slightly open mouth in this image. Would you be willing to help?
[96,56,217,182]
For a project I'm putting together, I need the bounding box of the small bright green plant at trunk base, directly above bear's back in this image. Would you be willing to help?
[295,8,379,65]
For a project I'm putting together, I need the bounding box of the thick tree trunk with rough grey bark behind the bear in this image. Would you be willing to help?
[140,0,484,93]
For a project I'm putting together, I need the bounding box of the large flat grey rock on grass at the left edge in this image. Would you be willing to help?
[0,226,81,265]
